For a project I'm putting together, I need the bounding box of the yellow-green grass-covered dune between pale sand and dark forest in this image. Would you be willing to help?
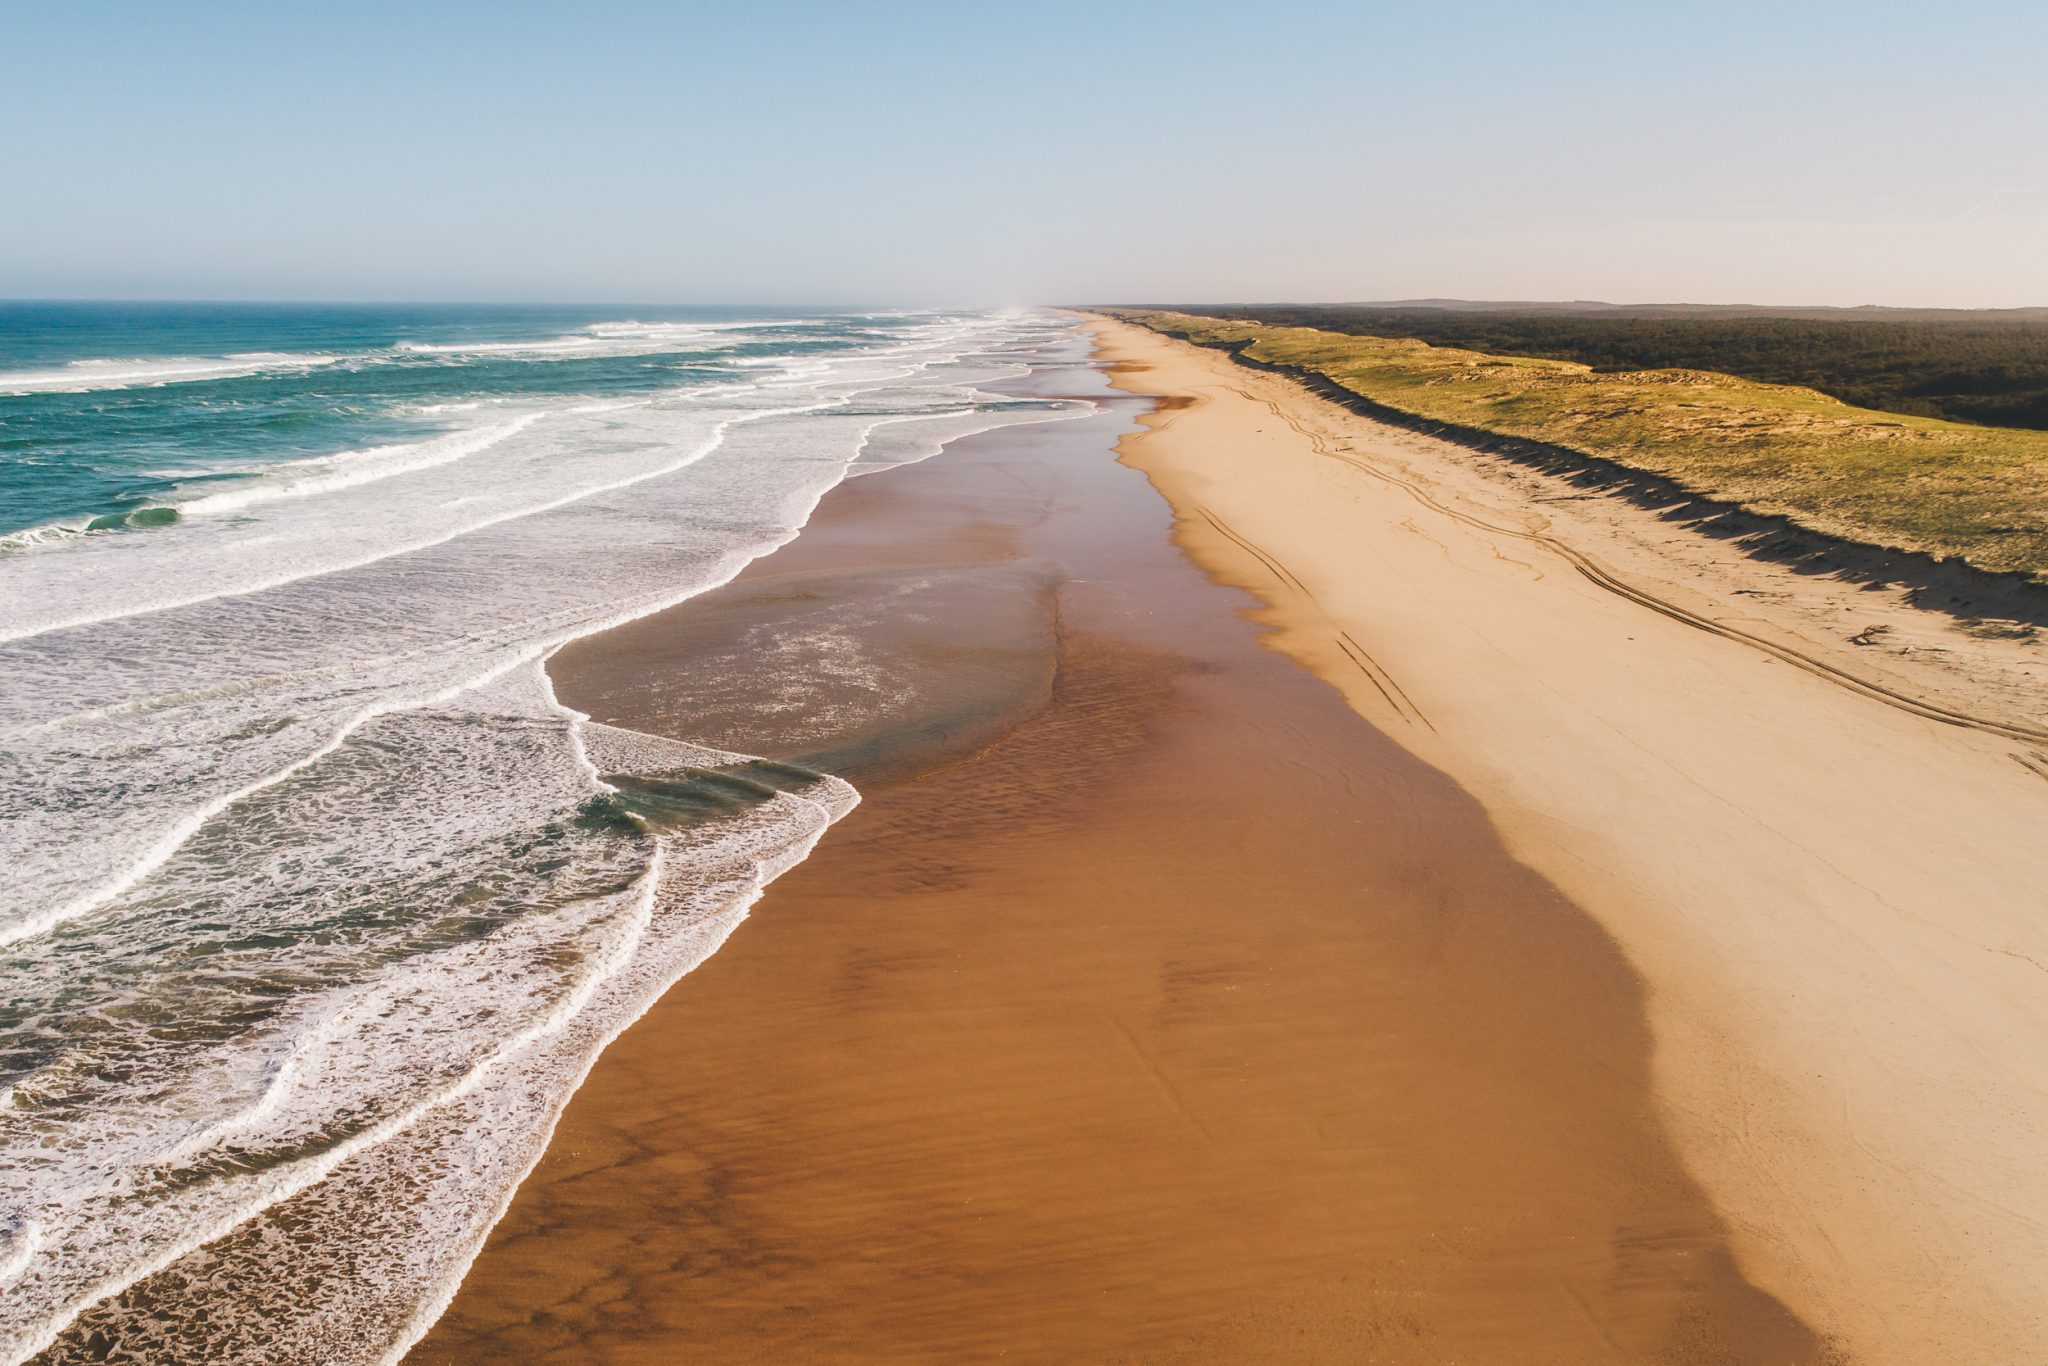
[1102,309,2048,586]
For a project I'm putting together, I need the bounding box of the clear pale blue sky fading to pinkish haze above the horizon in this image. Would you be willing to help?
[0,0,2048,307]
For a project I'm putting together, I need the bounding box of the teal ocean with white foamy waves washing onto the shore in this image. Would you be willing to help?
[0,303,1092,1362]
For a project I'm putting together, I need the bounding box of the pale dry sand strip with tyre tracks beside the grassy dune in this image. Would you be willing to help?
[1096,322,2048,1362]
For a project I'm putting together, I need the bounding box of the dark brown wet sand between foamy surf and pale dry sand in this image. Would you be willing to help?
[412,356,1821,1364]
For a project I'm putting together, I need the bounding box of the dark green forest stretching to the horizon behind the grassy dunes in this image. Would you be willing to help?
[1184,303,2048,428]
